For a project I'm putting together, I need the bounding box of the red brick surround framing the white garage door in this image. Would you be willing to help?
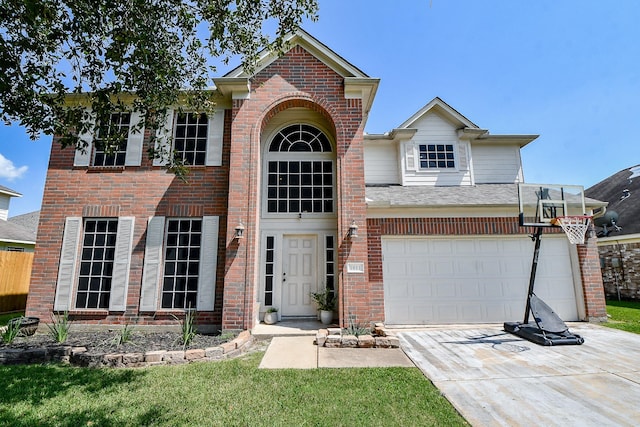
[367,217,607,321]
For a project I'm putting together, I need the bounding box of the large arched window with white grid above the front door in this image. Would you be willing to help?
[266,124,334,214]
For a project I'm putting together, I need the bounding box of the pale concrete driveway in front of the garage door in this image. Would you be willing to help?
[394,323,640,426]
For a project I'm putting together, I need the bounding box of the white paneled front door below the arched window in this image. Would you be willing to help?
[281,235,318,316]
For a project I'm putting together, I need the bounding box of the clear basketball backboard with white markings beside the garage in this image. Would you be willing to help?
[518,183,589,227]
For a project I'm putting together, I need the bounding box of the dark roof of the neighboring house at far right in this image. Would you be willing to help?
[585,165,640,236]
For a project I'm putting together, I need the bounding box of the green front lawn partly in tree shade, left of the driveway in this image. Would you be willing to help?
[0,353,467,427]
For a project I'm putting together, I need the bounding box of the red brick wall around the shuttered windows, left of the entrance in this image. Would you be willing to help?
[27,114,231,325]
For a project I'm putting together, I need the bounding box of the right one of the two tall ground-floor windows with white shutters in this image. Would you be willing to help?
[162,219,202,309]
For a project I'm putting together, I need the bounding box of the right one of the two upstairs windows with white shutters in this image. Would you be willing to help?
[173,113,209,166]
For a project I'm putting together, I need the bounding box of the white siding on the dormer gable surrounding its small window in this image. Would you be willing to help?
[400,112,472,186]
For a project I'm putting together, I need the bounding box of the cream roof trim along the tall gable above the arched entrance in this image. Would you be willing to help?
[224,29,369,78]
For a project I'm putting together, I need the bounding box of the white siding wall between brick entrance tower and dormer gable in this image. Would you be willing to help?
[364,141,400,184]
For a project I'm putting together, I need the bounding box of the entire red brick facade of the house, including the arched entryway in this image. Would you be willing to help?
[26,35,606,330]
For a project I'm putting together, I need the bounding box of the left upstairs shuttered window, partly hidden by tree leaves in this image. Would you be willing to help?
[93,113,131,166]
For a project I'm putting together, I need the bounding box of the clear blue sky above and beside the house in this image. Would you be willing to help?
[0,0,640,216]
